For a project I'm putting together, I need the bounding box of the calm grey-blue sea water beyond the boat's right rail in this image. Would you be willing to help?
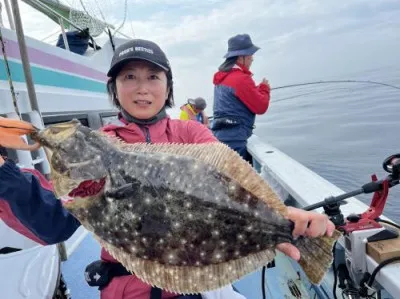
[254,67,400,222]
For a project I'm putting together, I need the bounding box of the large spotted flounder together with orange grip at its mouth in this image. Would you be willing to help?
[0,119,339,294]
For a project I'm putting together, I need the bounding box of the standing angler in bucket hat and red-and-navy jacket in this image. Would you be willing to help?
[211,34,270,163]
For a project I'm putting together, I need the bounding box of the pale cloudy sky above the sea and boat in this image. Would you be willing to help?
[2,0,400,111]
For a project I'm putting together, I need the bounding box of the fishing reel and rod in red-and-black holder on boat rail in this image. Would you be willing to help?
[304,153,400,298]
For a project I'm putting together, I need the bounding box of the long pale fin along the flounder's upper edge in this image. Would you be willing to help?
[100,133,287,216]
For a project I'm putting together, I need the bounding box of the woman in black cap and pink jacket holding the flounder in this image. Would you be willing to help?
[0,39,334,299]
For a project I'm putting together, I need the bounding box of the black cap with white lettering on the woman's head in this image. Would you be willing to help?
[107,39,170,77]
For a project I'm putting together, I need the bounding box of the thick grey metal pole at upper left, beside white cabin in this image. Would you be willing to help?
[11,0,40,114]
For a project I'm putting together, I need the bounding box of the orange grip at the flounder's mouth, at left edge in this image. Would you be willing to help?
[0,117,40,151]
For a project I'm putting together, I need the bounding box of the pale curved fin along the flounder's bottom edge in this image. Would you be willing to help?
[95,236,275,294]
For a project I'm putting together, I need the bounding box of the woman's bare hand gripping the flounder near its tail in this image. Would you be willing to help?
[277,207,335,261]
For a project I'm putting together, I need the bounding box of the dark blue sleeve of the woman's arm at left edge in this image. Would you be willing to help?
[0,160,80,244]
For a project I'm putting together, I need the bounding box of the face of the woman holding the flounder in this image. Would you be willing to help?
[116,61,169,119]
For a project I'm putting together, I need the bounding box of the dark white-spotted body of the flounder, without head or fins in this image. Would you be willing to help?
[70,152,292,266]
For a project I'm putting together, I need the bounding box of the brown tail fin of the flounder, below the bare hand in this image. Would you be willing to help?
[294,231,341,285]
